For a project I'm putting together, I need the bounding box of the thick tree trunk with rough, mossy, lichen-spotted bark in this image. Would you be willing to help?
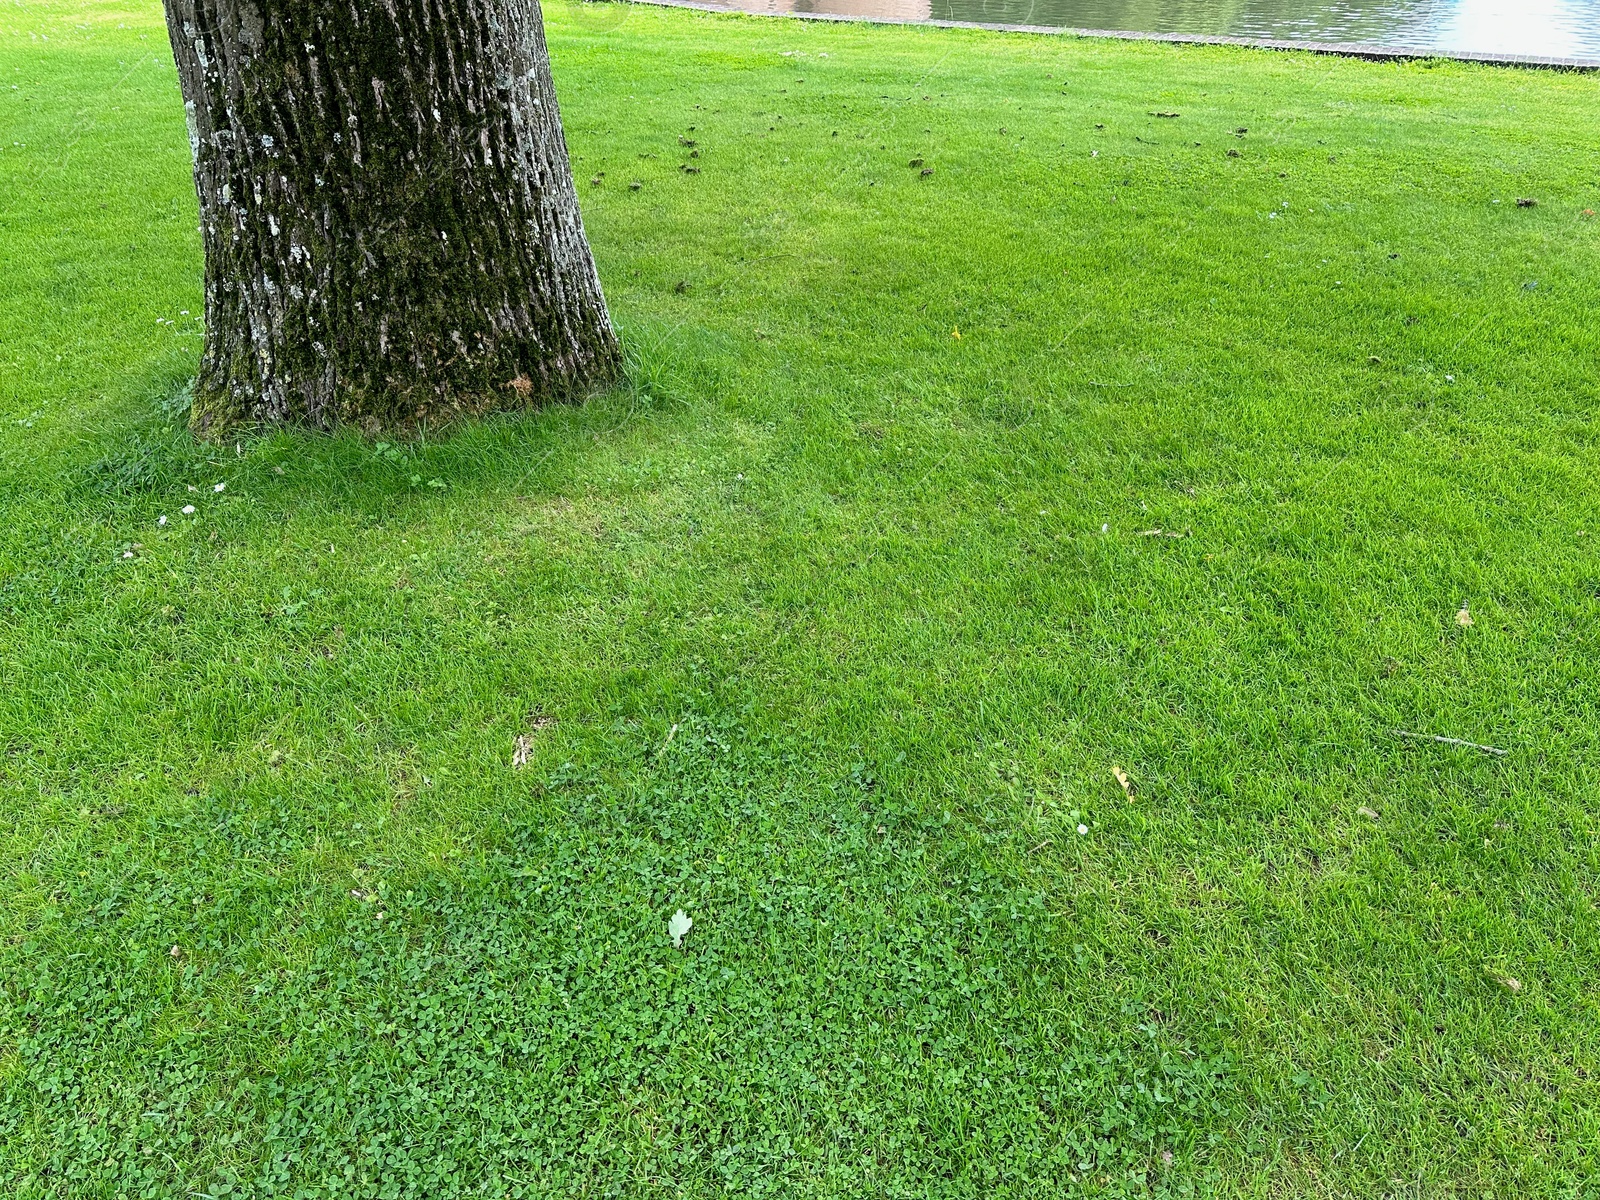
[166,0,619,434]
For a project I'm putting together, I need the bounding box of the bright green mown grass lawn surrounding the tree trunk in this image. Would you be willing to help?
[0,0,1600,1200]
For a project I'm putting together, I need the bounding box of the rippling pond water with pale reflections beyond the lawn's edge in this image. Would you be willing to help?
[684,0,1600,59]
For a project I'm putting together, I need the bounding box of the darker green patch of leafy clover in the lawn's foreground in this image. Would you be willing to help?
[0,694,1235,1197]
